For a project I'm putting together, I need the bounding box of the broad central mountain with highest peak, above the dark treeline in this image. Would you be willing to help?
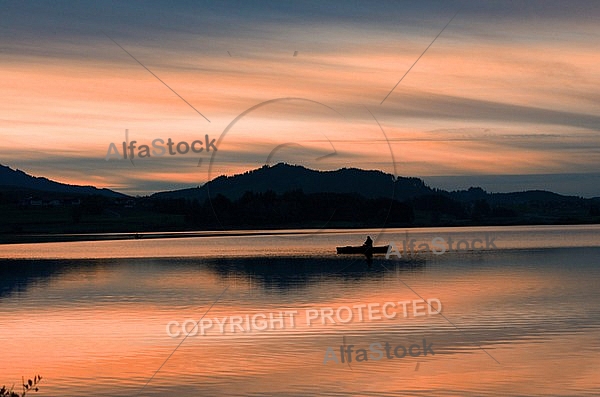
[152,163,435,200]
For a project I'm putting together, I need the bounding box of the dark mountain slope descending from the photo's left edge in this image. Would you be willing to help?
[0,164,128,198]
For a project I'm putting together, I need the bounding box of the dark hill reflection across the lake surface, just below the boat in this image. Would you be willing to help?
[0,256,427,298]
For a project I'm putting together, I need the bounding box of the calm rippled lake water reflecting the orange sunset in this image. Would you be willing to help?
[0,226,600,396]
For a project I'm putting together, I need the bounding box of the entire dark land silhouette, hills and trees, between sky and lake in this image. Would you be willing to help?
[0,164,600,243]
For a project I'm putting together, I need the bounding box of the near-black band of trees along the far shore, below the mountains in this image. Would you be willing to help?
[0,190,600,237]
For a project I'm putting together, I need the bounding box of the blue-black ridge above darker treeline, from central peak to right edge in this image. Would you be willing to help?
[151,163,598,206]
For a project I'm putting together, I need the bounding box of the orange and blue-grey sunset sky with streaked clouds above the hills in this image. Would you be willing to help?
[0,0,600,197]
